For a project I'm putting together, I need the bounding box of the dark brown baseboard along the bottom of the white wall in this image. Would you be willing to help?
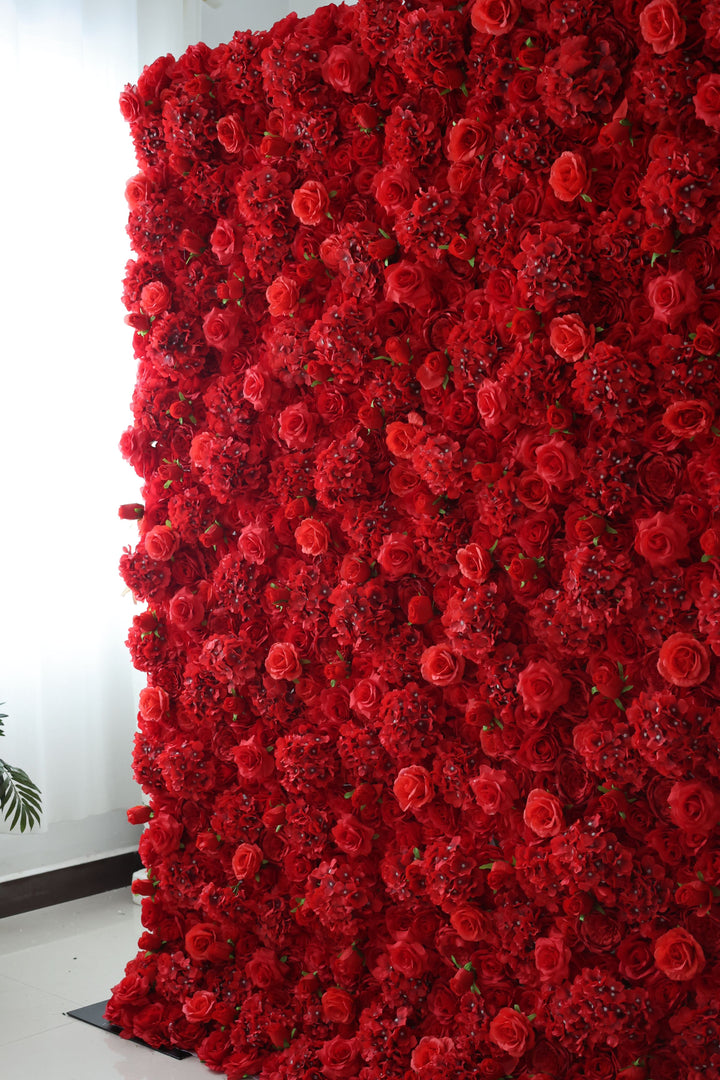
[0,851,142,919]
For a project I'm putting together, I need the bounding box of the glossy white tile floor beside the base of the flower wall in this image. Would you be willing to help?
[0,887,214,1080]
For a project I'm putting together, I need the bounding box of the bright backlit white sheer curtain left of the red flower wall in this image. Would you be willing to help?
[0,0,148,879]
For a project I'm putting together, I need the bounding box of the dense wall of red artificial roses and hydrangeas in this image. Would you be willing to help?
[108,0,720,1080]
